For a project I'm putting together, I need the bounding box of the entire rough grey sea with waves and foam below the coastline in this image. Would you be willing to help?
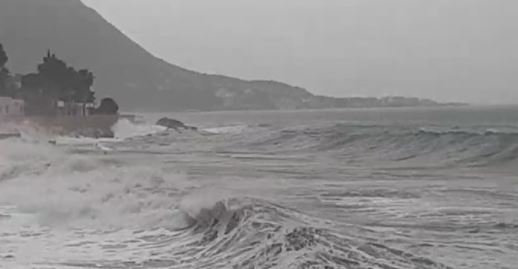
[0,107,518,269]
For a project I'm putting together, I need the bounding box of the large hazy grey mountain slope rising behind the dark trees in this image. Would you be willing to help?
[0,0,313,111]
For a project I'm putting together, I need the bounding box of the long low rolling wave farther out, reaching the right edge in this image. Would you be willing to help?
[229,124,518,166]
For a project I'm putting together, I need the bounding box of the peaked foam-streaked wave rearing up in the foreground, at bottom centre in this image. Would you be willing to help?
[108,199,449,269]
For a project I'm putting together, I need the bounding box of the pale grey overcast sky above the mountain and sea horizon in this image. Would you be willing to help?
[83,0,518,103]
